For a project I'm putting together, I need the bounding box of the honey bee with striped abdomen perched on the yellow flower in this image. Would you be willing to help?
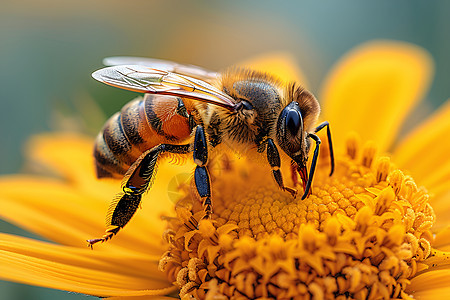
[88,57,334,247]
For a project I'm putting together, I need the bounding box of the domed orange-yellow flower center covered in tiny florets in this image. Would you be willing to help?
[160,137,435,299]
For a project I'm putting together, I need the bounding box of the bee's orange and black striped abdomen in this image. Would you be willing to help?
[94,94,191,178]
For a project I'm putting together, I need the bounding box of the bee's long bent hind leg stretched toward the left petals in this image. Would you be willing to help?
[87,144,190,247]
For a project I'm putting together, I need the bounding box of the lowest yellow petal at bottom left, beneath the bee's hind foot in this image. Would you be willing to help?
[0,234,173,296]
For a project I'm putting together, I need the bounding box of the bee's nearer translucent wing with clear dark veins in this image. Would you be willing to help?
[92,65,236,110]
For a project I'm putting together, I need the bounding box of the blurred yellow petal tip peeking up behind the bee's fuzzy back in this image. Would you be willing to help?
[237,52,308,87]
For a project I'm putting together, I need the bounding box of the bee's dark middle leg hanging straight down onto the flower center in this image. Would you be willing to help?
[193,125,212,219]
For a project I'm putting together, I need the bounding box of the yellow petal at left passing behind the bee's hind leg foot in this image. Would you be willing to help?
[0,172,183,253]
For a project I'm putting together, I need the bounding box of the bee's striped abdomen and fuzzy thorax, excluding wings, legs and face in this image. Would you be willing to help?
[94,69,319,178]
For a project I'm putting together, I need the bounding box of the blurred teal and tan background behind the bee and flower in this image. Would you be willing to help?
[0,0,450,300]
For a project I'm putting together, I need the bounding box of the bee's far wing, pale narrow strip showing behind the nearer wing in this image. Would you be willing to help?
[103,56,219,82]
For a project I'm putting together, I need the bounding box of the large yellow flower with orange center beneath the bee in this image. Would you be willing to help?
[0,42,450,299]
